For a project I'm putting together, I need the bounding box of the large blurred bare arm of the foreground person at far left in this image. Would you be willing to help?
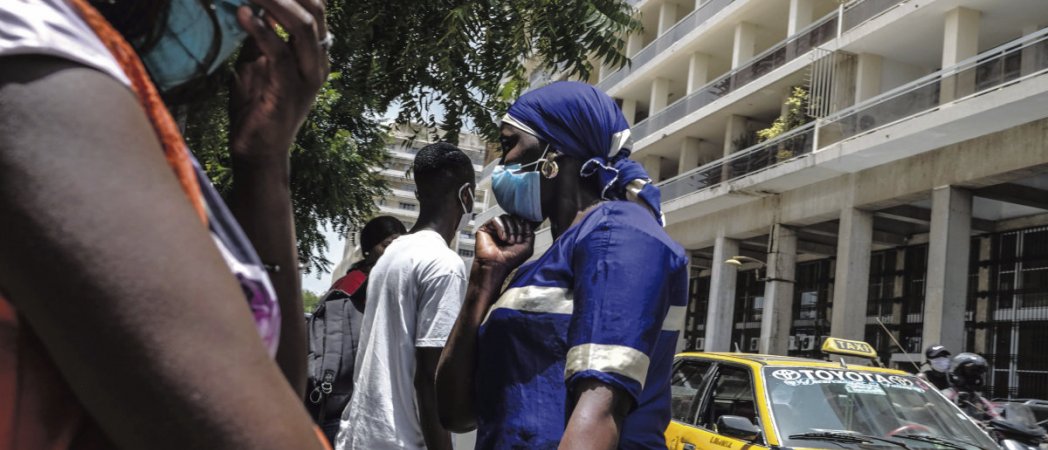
[0,57,322,450]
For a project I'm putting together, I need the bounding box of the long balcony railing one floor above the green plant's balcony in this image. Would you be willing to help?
[630,13,837,141]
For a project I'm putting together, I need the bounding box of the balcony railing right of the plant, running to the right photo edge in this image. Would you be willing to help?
[818,29,1048,148]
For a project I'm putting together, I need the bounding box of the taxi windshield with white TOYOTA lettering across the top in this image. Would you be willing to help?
[764,367,996,449]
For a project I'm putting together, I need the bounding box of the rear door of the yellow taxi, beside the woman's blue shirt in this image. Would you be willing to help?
[665,358,714,450]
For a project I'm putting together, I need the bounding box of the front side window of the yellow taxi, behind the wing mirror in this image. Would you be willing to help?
[697,364,757,430]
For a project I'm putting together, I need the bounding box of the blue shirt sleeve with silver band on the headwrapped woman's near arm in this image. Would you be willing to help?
[565,212,677,405]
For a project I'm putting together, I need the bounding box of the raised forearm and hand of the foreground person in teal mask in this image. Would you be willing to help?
[228,0,329,395]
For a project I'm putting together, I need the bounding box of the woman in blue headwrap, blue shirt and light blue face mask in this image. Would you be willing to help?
[437,82,687,449]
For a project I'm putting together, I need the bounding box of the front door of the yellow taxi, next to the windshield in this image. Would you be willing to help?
[671,362,768,450]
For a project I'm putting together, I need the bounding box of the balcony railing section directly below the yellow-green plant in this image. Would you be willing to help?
[659,123,815,201]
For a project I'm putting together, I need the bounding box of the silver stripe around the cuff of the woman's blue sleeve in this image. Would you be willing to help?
[564,344,651,389]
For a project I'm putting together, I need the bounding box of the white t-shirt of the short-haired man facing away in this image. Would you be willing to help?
[335,231,466,450]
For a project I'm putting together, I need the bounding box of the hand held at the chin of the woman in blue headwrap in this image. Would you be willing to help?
[474,214,534,273]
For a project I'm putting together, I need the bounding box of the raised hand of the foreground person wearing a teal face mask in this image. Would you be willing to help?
[230,0,330,165]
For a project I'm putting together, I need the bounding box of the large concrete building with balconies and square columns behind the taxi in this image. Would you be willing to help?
[481,0,1048,398]
